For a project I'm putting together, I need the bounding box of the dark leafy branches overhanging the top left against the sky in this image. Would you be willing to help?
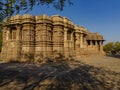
[0,0,72,21]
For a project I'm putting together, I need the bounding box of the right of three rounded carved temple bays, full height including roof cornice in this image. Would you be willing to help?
[52,15,64,53]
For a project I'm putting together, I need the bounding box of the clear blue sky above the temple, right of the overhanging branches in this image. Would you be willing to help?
[26,0,120,43]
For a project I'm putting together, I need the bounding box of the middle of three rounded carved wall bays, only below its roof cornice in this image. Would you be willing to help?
[35,23,52,56]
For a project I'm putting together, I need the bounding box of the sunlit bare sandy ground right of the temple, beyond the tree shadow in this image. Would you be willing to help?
[80,56,120,72]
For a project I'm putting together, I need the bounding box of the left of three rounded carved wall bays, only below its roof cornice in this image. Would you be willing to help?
[22,24,35,53]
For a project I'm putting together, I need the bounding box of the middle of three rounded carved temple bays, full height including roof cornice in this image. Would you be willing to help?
[35,15,53,56]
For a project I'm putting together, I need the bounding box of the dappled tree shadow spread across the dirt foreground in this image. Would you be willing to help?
[0,61,120,90]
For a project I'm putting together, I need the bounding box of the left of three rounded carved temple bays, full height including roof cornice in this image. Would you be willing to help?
[21,14,35,60]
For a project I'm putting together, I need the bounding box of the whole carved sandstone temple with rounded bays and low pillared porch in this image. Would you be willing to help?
[1,14,104,61]
